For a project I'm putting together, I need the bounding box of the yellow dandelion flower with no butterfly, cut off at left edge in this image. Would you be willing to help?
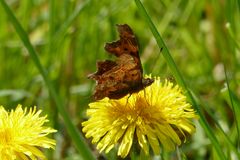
[0,105,56,160]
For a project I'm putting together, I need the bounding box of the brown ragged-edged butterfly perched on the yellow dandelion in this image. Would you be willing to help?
[88,24,154,100]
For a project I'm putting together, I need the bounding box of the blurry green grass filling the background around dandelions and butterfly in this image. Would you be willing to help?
[0,0,240,159]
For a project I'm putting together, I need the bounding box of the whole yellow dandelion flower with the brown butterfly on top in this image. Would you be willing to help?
[82,77,197,158]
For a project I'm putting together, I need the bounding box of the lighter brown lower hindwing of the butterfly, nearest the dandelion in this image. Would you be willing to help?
[90,54,141,100]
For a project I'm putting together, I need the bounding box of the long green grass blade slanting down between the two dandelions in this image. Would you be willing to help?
[0,0,95,159]
